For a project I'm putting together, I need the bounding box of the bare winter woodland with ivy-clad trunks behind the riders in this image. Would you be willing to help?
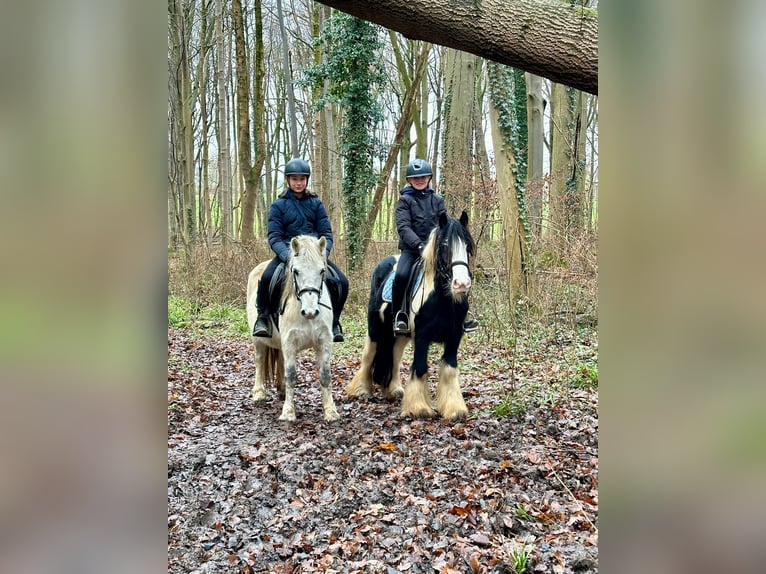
[168,0,598,316]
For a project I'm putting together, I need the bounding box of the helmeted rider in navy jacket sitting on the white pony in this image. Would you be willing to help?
[253,158,348,342]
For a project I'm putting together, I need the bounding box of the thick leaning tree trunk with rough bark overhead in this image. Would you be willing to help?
[319,0,598,95]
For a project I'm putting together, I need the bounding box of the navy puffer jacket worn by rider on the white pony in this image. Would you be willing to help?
[268,188,332,261]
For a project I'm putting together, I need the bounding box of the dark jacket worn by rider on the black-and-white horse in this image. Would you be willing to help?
[394,185,447,253]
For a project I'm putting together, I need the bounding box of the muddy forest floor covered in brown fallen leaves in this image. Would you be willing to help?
[168,327,598,574]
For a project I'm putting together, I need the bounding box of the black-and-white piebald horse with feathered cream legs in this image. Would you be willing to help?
[346,212,474,420]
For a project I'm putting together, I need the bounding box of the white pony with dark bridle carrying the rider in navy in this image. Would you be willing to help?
[247,235,340,422]
